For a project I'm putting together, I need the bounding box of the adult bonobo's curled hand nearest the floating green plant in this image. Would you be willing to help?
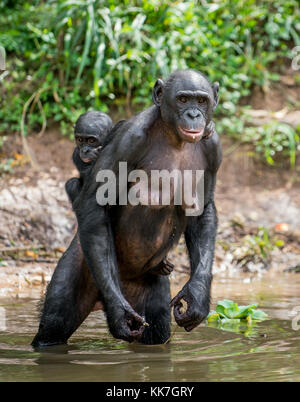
[170,281,209,331]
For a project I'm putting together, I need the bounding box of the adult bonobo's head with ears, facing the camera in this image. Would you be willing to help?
[153,70,219,142]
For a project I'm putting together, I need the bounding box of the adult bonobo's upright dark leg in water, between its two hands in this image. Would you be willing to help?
[140,274,171,345]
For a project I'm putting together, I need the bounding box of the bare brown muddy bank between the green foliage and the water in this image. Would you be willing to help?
[0,74,300,296]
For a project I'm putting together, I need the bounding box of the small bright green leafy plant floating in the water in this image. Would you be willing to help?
[207,300,268,336]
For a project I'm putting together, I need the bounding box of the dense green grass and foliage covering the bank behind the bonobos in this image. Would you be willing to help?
[0,0,300,166]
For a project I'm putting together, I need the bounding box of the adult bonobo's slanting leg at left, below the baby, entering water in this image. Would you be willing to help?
[32,234,99,347]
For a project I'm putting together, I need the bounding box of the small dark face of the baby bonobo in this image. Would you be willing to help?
[75,133,102,163]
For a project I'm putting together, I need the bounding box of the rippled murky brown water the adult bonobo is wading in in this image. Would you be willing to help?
[0,274,300,381]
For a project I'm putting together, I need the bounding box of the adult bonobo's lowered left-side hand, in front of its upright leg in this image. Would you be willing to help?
[107,303,148,342]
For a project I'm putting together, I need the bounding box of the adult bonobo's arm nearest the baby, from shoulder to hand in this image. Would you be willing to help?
[73,108,156,342]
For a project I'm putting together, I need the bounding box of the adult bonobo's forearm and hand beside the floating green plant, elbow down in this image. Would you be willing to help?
[171,200,217,331]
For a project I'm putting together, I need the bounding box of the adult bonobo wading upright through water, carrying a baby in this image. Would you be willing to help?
[33,70,221,345]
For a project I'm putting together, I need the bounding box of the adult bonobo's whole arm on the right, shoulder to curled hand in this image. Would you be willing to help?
[171,131,222,331]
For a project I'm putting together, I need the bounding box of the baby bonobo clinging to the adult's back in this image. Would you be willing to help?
[66,111,113,204]
